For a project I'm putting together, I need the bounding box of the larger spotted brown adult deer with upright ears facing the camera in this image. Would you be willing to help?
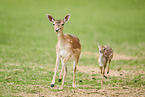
[46,14,81,89]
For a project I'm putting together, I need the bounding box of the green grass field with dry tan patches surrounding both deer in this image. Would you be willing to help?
[0,0,145,97]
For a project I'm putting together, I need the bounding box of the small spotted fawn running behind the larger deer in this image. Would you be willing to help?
[98,45,113,84]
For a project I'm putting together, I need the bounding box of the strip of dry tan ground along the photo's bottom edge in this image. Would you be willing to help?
[13,85,145,97]
